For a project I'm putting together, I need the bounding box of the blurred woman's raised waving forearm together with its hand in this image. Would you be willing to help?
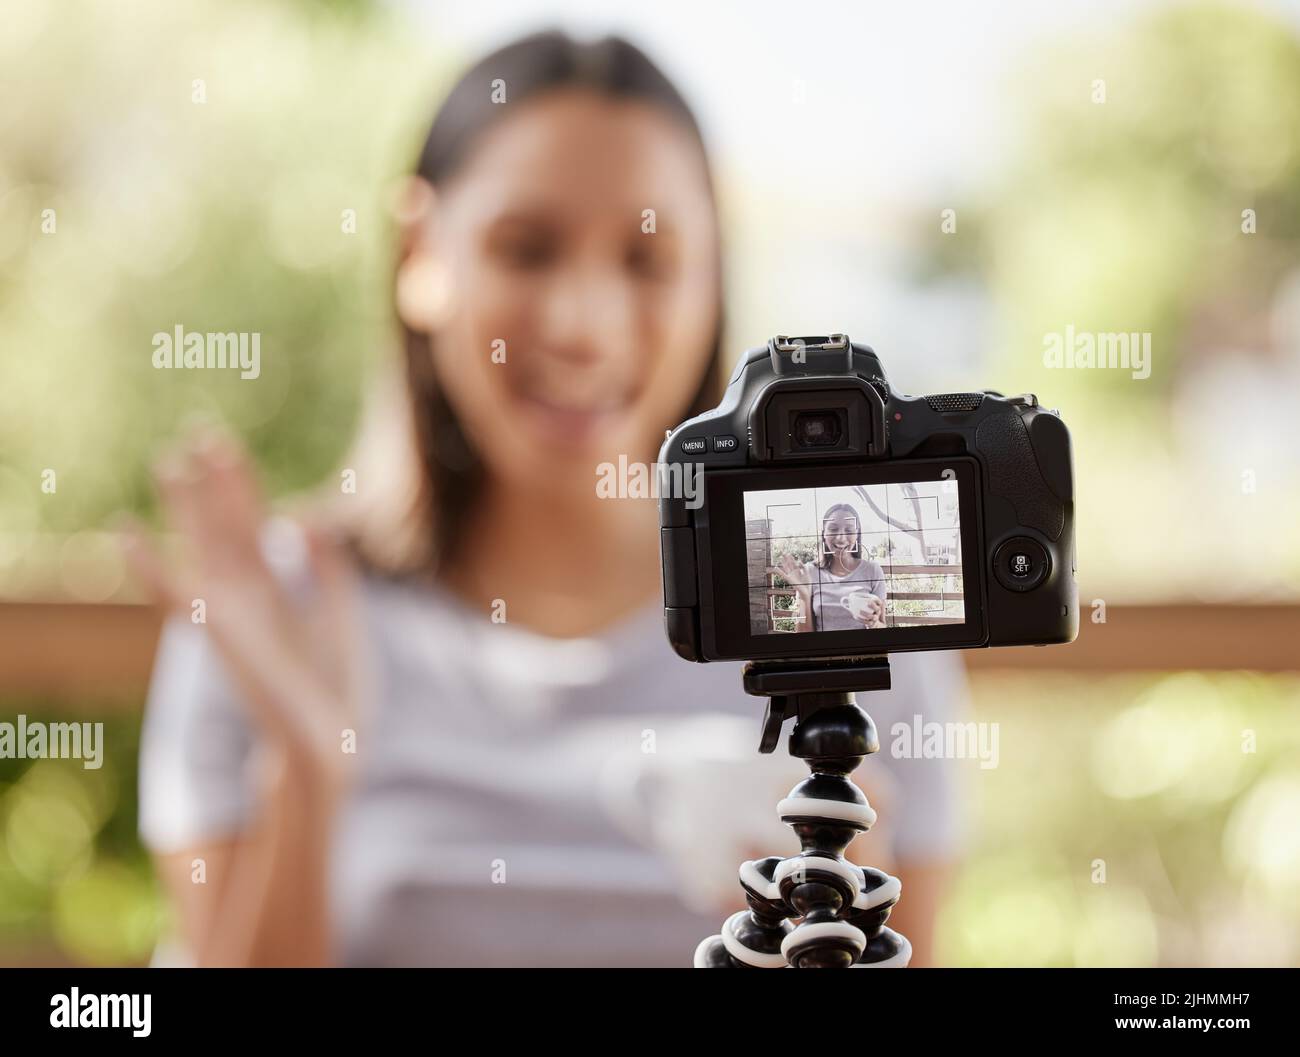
[127,426,365,966]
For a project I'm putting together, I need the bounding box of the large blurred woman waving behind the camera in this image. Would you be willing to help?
[130,26,959,965]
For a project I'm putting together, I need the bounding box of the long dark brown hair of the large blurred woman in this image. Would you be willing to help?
[354,30,723,576]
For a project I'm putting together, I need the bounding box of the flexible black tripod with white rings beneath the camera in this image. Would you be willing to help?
[694,657,911,969]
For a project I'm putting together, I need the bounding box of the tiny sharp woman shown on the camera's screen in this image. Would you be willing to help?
[780,503,885,632]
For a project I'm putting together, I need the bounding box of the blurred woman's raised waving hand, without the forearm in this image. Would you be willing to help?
[125,429,361,792]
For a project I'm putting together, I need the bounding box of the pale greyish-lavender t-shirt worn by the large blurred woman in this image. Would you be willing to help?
[139,527,966,966]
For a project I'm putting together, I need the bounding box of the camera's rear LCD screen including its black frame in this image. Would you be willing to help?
[697,455,987,659]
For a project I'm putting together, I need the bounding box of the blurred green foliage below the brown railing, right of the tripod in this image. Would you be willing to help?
[939,672,1300,966]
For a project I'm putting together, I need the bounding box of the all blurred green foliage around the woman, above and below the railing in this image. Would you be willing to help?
[0,0,1300,965]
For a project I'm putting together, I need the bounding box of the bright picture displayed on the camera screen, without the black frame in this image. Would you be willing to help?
[745,480,966,634]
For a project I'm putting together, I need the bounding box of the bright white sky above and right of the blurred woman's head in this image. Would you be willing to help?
[391,0,1300,382]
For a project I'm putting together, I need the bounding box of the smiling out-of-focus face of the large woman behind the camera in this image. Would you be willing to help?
[399,90,719,489]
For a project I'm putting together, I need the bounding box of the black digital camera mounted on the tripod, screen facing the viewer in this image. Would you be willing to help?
[658,334,1079,662]
